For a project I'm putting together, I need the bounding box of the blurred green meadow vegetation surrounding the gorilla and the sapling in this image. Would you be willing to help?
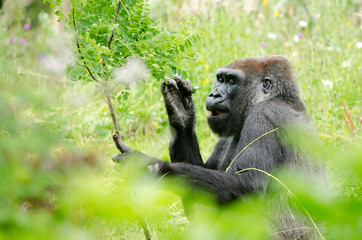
[0,0,362,239]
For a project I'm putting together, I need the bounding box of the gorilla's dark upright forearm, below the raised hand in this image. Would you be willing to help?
[170,126,204,166]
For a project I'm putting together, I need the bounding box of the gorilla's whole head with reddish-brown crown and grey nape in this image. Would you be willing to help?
[206,56,304,137]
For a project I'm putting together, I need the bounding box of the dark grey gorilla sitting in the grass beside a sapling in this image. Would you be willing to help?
[114,56,320,239]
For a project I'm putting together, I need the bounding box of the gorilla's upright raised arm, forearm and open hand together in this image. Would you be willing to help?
[161,75,204,166]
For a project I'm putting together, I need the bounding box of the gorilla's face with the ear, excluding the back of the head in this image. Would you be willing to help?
[206,58,276,137]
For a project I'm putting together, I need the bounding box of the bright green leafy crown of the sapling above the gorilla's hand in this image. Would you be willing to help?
[45,0,200,80]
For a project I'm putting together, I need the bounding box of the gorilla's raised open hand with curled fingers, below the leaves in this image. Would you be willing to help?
[161,75,195,130]
